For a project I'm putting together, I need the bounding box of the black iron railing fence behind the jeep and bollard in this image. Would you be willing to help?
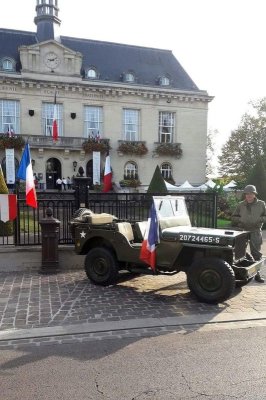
[0,191,217,246]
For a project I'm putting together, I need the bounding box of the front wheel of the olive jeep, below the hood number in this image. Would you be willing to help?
[187,258,235,303]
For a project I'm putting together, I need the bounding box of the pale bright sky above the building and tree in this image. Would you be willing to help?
[0,0,266,148]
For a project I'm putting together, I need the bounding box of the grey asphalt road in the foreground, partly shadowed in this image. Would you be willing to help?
[0,327,266,400]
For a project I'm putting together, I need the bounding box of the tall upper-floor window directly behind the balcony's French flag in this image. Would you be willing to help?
[42,103,63,136]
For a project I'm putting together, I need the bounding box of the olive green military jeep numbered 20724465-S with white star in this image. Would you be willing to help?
[70,196,262,303]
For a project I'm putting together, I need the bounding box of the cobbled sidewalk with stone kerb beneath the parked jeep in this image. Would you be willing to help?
[0,233,266,343]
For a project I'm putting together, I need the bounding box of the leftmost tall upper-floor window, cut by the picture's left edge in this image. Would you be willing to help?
[0,100,20,134]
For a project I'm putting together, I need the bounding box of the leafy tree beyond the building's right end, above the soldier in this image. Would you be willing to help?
[219,98,266,180]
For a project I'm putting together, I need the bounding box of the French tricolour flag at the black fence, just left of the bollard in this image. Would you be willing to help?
[17,143,37,208]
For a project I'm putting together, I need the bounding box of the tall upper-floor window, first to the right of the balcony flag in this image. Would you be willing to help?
[84,106,103,139]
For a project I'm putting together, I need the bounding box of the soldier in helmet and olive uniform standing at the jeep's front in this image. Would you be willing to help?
[232,185,266,283]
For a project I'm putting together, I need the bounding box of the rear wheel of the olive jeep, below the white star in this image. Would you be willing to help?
[85,247,118,286]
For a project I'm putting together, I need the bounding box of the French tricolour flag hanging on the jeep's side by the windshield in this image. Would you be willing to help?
[139,201,160,271]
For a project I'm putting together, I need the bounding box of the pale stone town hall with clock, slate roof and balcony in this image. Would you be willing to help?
[0,0,212,188]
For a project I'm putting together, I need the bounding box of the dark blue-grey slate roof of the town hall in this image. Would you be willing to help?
[0,29,199,91]
